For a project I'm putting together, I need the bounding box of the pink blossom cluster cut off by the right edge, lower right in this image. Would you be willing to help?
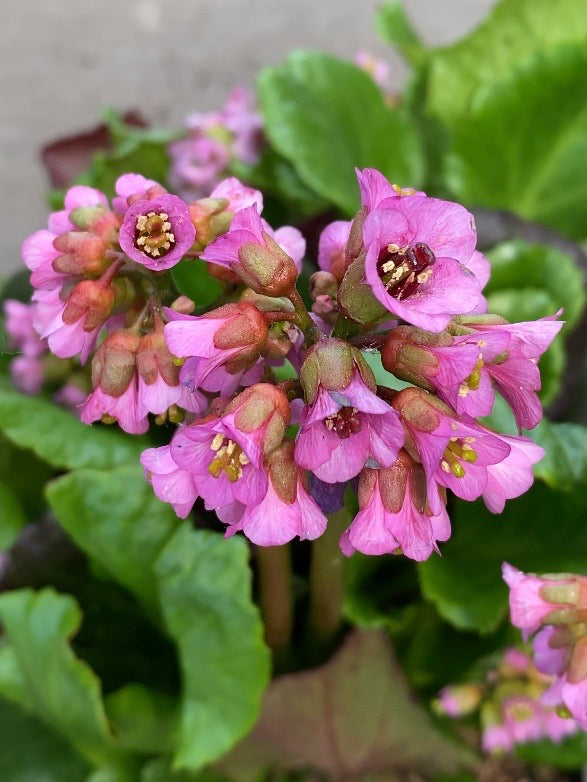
[503,562,587,730]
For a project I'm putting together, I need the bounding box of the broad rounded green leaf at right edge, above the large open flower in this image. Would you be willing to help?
[446,47,587,238]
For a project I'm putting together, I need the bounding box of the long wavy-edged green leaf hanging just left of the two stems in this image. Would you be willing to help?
[156,525,269,770]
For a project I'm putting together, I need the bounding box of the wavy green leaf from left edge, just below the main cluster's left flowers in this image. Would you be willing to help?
[0,384,148,469]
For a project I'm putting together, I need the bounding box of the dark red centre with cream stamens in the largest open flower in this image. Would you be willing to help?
[377,242,436,301]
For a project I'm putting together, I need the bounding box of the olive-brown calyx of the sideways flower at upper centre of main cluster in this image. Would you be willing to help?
[237,233,298,296]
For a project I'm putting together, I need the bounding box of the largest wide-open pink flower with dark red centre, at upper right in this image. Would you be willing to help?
[363,195,482,332]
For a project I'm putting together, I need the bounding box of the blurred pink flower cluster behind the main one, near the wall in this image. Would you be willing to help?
[169,87,263,200]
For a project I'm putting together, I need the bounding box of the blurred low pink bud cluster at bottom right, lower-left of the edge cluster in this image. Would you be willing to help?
[434,648,580,754]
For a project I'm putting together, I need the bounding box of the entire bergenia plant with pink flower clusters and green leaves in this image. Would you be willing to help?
[0,0,587,782]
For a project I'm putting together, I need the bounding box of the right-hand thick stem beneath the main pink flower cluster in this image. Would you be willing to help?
[308,508,349,656]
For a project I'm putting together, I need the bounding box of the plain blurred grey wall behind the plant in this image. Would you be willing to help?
[0,0,494,273]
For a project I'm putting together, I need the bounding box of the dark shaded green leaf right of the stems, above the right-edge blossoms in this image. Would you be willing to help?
[418,483,587,632]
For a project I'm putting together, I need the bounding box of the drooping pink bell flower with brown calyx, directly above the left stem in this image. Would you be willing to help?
[225,440,327,546]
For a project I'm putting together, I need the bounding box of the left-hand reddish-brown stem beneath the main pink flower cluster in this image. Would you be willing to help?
[256,545,294,667]
